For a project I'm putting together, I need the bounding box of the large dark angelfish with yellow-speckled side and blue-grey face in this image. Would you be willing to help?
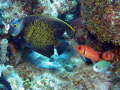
[8,15,74,57]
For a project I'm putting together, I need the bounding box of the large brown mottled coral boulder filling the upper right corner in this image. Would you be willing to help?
[80,0,120,45]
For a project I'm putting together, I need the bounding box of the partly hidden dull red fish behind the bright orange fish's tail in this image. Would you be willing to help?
[101,50,115,60]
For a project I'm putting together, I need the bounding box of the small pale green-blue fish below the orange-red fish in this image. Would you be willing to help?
[93,61,115,72]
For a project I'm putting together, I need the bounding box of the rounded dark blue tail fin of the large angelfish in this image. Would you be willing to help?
[56,41,69,55]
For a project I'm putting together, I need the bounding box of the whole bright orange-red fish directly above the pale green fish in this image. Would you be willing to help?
[77,45,102,61]
